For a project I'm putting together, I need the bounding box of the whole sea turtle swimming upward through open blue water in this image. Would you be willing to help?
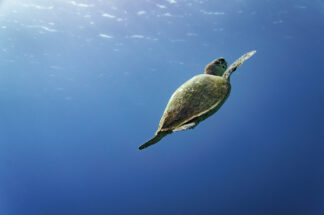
[139,51,256,150]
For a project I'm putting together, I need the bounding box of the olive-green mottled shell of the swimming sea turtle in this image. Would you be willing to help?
[157,74,231,133]
